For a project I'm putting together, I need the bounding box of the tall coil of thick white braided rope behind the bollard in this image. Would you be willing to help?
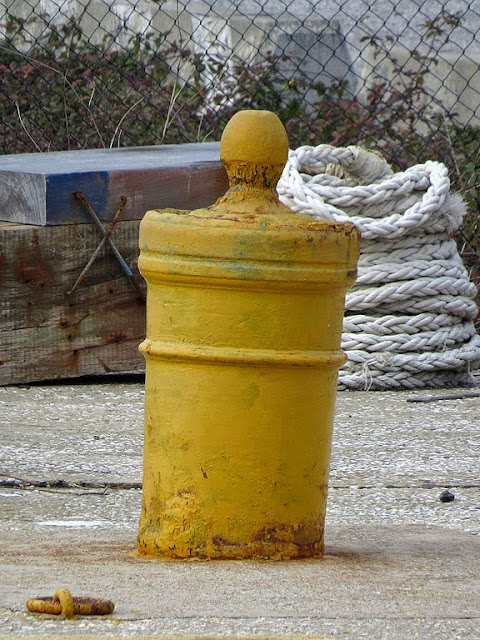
[278,145,480,389]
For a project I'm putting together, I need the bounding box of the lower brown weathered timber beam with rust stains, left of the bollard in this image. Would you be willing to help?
[0,221,145,384]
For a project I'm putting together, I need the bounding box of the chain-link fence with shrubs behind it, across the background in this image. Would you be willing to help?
[0,0,480,225]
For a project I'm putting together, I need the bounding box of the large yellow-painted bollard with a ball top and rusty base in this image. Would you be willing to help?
[138,111,359,560]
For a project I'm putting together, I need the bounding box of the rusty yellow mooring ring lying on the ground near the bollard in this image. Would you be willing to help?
[27,589,115,618]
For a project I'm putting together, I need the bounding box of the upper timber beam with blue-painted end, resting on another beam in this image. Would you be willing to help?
[0,142,228,226]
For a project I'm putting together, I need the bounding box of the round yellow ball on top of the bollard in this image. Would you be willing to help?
[220,110,288,168]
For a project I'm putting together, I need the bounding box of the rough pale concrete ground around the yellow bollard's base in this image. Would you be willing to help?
[0,378,480,640]
